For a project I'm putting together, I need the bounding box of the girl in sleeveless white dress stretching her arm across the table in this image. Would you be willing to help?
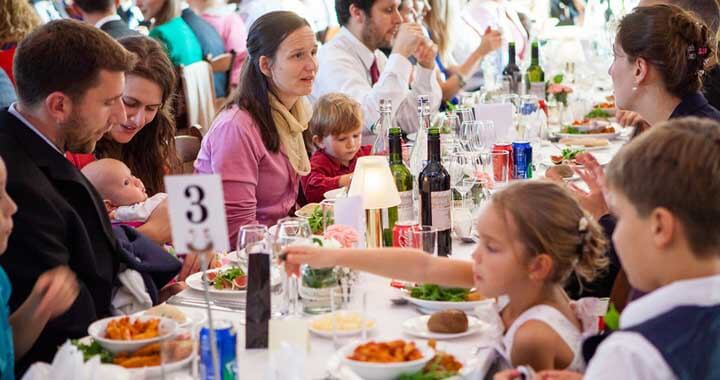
[286,181,607,371]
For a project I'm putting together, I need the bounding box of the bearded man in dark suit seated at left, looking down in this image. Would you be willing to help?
[0,20,135,375]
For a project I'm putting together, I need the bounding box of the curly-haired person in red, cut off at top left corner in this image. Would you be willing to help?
[0,0,41,83]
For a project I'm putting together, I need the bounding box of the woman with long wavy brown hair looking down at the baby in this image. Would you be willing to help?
[66,36,179,242]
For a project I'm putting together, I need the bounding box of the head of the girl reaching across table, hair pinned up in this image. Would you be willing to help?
[473,181,608,297]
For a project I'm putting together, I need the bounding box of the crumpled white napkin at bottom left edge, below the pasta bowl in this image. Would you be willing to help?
[22,341,131,380]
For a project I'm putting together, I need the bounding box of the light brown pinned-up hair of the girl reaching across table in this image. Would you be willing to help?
[492,181,609,284]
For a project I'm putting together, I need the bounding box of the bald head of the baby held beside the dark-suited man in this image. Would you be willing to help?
[82,158,147,207]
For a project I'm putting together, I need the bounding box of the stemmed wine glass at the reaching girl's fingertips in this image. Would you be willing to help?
[273,217,312,315]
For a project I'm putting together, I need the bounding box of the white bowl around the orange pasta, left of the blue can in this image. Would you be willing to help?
[88,315,177,354]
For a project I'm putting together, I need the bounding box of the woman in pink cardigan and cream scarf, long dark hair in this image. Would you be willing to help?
[195,11,317,246]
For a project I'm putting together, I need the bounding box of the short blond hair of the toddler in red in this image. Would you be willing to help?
[308,92,363,139]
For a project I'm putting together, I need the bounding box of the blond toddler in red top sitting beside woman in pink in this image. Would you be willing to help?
[300,93,371,202]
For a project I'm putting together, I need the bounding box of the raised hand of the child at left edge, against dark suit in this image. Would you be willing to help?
[30,266,79,320]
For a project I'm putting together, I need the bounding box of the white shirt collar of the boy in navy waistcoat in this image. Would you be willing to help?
[620,275,720,328]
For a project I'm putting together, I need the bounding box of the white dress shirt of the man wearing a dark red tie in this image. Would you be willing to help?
[312,27,442,143]
